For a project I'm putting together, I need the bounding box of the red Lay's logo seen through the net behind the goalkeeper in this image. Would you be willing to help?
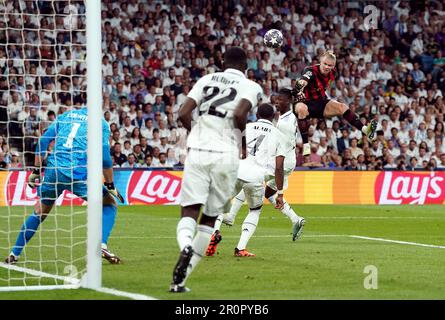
[5,171,86,206]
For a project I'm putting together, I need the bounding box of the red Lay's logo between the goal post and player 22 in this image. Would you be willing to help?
[127,171,181,205]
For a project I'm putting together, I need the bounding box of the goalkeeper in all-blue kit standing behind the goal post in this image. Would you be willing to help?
[5,107,123,264]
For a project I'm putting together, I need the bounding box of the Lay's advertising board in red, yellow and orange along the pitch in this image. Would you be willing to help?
[0,170,445,206]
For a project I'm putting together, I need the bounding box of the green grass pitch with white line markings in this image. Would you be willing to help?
[0,205,445,300]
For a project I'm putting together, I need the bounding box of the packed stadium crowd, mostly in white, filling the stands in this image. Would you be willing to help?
[0,0,445,170]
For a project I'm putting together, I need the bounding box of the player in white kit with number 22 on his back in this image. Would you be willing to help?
[170,47,263,292]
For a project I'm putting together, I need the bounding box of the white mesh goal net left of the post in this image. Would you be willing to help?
[0,0,100,291]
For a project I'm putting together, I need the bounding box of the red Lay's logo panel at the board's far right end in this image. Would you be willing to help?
[374,172,445,204]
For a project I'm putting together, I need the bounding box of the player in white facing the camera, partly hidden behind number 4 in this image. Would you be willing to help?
[223,88,305,241]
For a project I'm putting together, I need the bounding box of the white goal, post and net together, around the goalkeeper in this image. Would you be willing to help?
[0,0,103,292]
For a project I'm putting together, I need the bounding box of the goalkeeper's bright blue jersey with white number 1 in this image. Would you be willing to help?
[36,107,112,180]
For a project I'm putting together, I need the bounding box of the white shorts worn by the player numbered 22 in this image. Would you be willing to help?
[180,149,239,217]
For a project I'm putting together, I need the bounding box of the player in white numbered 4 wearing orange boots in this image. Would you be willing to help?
[206,103,286,257]
